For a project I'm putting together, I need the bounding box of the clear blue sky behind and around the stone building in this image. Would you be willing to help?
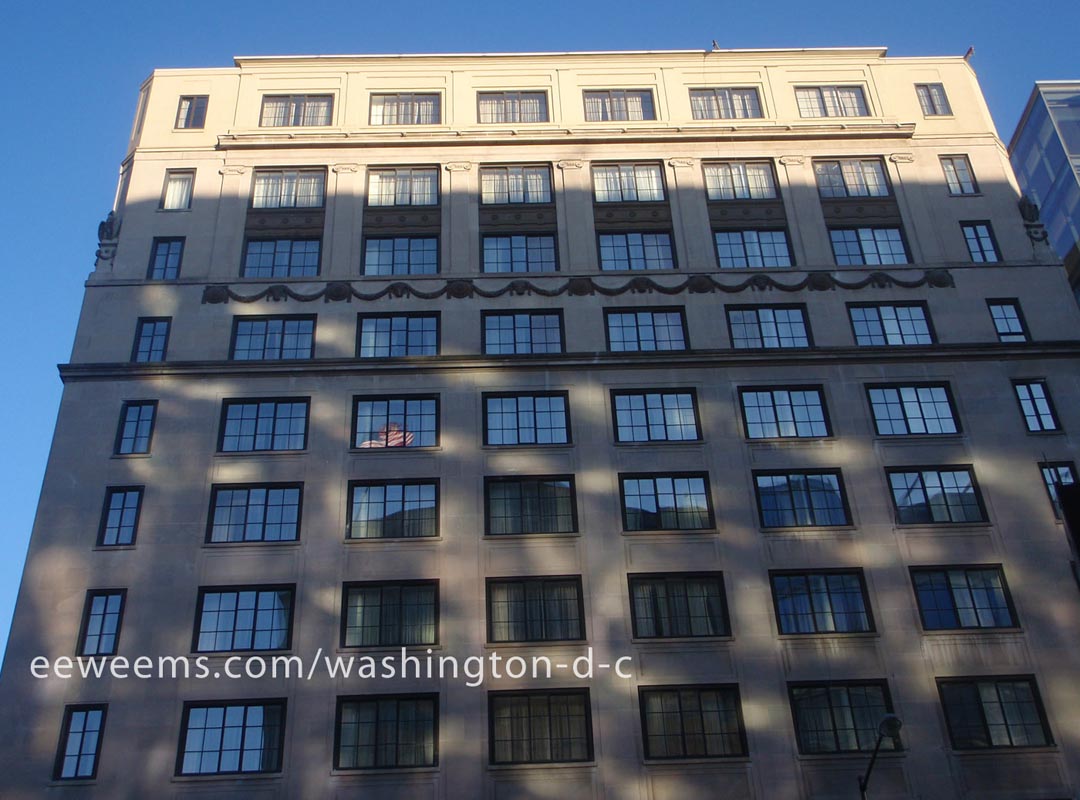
[0,0,1080,643]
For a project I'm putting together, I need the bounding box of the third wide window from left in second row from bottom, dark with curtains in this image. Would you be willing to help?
[487,578,585,642]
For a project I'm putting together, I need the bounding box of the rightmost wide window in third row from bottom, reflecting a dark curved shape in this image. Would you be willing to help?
[887,467,986,525]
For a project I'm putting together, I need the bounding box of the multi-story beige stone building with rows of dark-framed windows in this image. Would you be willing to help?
[0,49,1080,800]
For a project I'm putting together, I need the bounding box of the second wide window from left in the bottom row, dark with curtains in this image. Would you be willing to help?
[334,694,438,770]
